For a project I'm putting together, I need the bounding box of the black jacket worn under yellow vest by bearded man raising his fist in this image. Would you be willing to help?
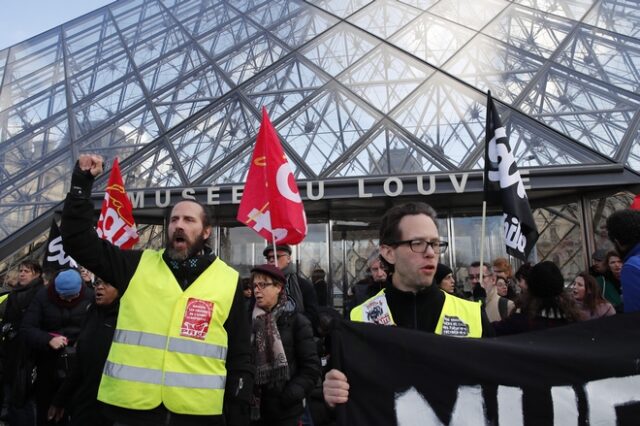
[60,165,254,426]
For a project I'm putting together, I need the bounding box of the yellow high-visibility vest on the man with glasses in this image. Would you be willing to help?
[349,289,482,337]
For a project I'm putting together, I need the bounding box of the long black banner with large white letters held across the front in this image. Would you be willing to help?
[331,312,640,426]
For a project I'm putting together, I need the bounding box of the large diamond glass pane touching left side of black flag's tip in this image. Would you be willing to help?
[391,74,486,167]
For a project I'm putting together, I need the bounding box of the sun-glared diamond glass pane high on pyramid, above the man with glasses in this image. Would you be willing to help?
[389,13,475,66]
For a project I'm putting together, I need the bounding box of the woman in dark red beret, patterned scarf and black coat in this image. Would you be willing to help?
[251,264,321,426]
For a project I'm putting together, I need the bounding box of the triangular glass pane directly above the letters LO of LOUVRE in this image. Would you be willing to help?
[332,126,442,177]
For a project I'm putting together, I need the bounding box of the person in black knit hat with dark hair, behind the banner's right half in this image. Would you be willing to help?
[492,261,582,336]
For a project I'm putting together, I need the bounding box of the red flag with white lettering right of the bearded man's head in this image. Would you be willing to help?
[236,107,307,244]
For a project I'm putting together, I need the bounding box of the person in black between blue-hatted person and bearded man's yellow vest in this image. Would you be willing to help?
[49,278,120,426]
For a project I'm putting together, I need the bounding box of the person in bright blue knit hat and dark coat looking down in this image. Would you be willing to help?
[21,269,93,425]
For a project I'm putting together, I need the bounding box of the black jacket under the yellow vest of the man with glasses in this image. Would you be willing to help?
[385,276,495,337]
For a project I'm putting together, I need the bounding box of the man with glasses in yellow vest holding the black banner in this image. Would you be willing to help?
[323,203,493,406]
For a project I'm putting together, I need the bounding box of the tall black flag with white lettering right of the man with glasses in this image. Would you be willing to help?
[484,92,538,260]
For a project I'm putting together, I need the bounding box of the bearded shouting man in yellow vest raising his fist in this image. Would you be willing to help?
[61,154,254,426]
